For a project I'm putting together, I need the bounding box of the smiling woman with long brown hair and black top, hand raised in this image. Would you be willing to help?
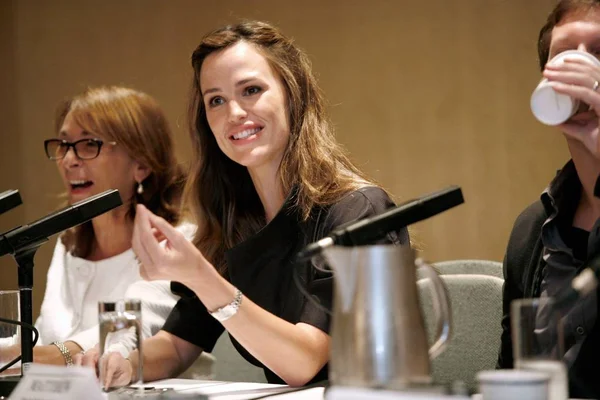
[90,21,408,386]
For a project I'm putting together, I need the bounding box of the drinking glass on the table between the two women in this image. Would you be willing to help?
[98,299,143,387]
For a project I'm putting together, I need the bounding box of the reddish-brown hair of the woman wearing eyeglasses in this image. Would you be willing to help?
[55,86,185,257]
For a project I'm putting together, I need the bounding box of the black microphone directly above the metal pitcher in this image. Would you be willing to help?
[297,185,464,261]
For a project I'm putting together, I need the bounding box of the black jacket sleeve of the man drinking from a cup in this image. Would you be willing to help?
[497,201,546,368]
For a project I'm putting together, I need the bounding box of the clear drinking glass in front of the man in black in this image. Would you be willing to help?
[511,297,569,400]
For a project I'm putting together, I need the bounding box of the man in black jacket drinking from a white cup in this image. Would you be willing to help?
[498,0,600,398]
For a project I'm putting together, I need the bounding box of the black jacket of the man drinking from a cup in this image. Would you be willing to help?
[498,162,600,398]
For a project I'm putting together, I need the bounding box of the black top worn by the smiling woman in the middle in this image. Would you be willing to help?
[163,187,408,383]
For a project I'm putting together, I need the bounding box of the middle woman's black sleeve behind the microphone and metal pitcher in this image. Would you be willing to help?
[299,187,409,332]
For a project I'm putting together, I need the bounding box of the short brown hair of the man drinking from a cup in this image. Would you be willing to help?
[538,0,600,71]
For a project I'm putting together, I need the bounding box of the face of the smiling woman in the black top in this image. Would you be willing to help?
[200,42,290,176]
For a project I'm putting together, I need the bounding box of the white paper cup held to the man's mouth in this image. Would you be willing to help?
[530,50,600,125]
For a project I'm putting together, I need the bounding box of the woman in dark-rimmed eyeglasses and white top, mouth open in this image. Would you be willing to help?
[18,87,202,365]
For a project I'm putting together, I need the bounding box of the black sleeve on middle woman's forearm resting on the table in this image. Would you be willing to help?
[162,282,225,352]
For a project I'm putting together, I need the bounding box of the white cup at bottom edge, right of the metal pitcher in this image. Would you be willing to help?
[477,369,550,400]
